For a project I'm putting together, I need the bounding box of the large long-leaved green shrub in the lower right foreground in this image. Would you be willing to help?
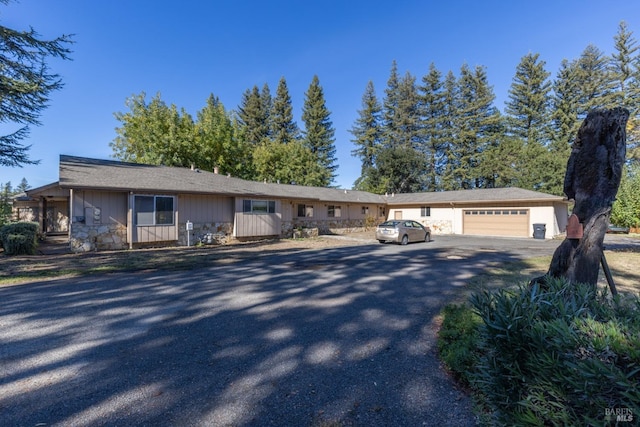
[469,280,640,425]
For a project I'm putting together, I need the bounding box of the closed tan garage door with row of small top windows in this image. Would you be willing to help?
[462,209,533,237]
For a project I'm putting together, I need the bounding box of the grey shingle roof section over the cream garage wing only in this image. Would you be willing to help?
[385,187,566,206]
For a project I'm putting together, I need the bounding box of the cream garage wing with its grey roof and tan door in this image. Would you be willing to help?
[386,188,569,238]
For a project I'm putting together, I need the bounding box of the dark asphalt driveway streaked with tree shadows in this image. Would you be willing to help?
[0,236,560,426]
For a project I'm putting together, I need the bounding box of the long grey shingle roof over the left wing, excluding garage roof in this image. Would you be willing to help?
[59,155,384,204]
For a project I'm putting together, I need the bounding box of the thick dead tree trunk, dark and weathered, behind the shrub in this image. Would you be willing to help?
[532,108,629,287]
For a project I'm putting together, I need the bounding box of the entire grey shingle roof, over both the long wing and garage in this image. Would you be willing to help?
[58,155,565,206]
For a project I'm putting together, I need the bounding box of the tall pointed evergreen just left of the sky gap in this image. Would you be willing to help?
[302,76,338,187]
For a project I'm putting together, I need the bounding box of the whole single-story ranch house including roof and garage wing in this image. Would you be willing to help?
[16,155,568,252]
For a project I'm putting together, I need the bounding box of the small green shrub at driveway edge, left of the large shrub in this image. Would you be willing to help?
[438,304,482,385]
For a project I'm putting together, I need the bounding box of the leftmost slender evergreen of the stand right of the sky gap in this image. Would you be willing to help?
[349,80,384,193]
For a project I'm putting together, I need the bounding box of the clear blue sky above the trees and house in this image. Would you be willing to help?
[0,0,640,188]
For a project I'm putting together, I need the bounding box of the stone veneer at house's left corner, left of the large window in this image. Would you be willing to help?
[69,222,129,252]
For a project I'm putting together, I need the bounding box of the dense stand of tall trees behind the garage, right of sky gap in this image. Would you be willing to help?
[351,22,640,195]
